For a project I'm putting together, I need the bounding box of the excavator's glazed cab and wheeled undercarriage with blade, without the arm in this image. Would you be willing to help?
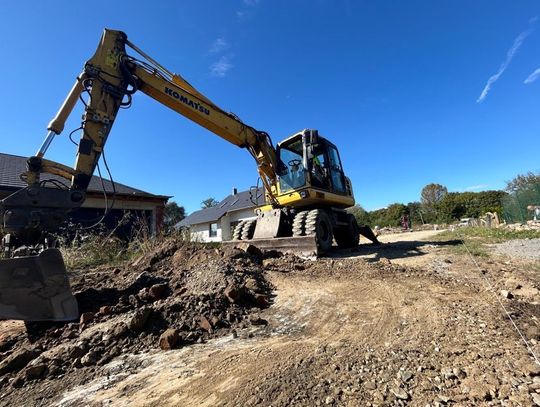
[243,129,378,257]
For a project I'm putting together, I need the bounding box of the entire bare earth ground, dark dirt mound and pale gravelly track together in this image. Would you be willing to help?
[0,231,540,407]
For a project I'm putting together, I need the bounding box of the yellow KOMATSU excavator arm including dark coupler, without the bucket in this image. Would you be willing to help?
[0,30,280,253]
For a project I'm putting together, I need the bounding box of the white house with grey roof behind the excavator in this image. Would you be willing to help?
[176,188,264,242]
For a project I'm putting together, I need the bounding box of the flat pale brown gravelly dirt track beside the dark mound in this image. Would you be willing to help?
[42,231,540,406]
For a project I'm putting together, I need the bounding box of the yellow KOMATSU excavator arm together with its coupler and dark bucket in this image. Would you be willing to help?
[0,30,279,320]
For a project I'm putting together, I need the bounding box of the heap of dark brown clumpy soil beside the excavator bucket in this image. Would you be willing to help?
[0,241,271,391]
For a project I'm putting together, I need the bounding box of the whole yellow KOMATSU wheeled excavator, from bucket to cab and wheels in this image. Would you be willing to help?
[0,29,377,321]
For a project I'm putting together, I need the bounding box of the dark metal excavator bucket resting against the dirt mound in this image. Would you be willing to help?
[0,249,79,321]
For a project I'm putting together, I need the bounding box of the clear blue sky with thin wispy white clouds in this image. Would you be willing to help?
[0,0,540,213]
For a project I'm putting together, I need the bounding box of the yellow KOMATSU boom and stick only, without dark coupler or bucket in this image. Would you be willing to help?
[34,29,277,205]
